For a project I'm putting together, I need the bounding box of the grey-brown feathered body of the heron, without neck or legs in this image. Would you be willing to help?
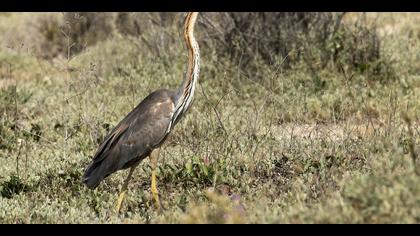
[85,89,175,188]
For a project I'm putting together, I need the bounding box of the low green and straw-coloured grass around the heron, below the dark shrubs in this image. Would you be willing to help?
[0,13,420,223]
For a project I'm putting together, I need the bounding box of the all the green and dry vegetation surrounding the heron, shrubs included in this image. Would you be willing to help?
[0,13,420,223]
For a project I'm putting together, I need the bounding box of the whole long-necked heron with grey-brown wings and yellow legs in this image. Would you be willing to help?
[83,12,200,212]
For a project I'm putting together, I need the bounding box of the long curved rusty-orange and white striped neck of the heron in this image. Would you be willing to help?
[174,12,200,123]
